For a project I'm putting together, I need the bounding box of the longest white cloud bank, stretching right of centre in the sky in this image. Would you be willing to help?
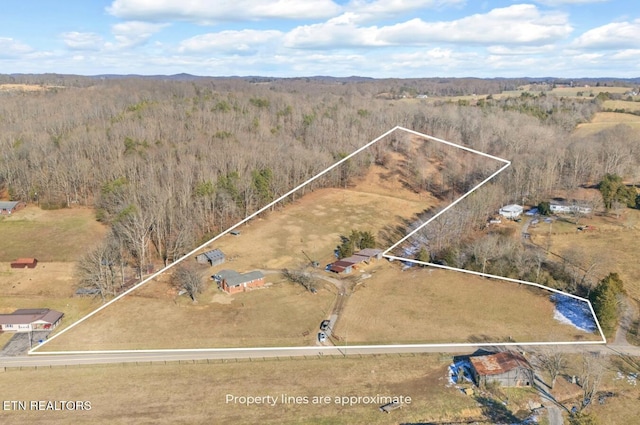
[285,4,573,49]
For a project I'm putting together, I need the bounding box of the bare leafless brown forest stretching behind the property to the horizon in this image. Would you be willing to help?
[0,75,640,295]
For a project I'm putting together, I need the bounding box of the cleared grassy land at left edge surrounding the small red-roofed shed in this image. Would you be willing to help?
[0,206,106,338]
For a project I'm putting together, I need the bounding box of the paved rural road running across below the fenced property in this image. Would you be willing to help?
[5,344,640,368]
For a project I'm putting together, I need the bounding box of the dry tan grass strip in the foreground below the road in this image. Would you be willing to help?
[0,355,490,425]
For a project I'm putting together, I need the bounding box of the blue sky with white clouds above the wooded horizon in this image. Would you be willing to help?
[0,0,640,78]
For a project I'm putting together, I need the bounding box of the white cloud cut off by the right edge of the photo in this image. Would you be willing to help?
[574,19,640,49]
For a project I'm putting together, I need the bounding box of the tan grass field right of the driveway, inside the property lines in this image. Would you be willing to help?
[334,264,601,344]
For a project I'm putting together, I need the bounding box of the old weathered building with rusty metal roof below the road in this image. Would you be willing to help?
[469,351,534,387]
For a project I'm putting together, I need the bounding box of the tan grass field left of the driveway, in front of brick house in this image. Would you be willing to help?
[41,275,336,351]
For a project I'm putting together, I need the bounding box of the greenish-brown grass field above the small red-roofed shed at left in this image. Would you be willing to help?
[0,205,107,262]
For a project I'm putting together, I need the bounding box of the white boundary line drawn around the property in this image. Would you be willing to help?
[28,126,606,355]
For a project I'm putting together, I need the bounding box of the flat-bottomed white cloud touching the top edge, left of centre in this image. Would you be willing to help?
[107,0,341,23]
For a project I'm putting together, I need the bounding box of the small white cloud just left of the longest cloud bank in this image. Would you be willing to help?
[178,30,283,55]
